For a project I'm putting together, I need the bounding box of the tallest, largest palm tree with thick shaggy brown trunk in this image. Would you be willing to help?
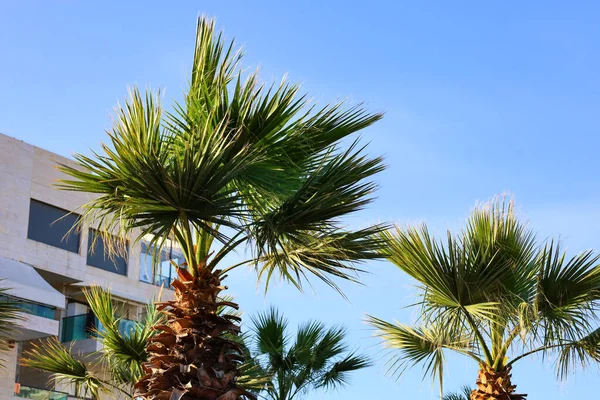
[59,18,384,400]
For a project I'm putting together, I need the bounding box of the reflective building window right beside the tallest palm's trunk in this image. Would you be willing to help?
[140,240,185,287]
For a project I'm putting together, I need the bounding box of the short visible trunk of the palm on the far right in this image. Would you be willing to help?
[471,365,527,400]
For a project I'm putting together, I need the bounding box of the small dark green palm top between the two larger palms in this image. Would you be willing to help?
[246,308,370,400]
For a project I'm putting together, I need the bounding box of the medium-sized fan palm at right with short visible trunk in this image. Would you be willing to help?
[369,199,600,400]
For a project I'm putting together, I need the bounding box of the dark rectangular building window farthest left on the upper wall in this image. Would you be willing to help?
[27,199,80,253]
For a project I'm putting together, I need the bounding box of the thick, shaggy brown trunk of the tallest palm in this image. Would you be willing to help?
[135,262,255,400]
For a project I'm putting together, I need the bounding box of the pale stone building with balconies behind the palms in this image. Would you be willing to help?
[0,134,177,400]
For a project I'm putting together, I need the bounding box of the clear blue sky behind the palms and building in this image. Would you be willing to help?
[0,0,600,400]
